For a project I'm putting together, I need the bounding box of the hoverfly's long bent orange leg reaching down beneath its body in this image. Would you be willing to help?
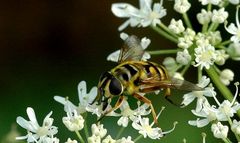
[133,93,159,126]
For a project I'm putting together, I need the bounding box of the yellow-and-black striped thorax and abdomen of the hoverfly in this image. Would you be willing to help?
[110,61,168,94]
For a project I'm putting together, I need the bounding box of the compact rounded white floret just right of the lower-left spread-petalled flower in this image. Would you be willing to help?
[62,108,84,132]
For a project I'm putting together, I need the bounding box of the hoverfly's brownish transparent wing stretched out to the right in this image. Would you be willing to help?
[141,77,203,91]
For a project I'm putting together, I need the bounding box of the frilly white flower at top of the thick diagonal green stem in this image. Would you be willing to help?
[194,45,217,69]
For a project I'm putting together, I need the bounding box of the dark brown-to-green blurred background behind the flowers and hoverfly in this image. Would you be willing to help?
[0,0,238,142]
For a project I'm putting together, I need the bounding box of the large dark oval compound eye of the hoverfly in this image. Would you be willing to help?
[109,77,123,95]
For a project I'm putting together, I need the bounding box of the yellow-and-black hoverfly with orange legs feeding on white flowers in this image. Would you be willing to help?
[93,35,202,124]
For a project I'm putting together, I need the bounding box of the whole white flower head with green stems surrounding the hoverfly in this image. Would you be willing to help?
[17,0,240,143]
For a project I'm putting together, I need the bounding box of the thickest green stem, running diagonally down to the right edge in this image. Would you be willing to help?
[206,67,240,117]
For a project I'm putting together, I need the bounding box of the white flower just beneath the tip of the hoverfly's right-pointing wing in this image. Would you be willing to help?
[182,76,216,112]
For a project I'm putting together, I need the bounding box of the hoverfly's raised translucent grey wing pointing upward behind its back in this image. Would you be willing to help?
[118,35,144,63]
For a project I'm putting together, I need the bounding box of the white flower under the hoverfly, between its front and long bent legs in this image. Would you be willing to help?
[117,100,151,127]
